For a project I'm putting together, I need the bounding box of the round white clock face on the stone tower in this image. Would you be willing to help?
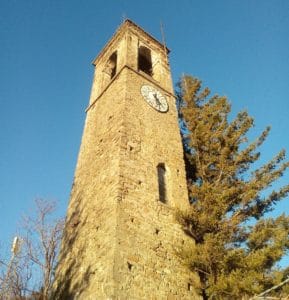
[141,85,169,112]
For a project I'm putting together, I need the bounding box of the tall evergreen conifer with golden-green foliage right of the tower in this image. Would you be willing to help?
[177,76,289,299]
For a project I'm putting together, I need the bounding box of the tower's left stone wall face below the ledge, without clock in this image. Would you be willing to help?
[53,72,125,299]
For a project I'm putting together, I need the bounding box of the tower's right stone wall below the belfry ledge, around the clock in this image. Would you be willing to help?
[113,69,197,299]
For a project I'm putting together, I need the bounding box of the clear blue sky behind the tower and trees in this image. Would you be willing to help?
[0,0,289,262]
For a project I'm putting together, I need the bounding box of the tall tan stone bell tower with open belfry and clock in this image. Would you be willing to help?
[53,20,197,300]
